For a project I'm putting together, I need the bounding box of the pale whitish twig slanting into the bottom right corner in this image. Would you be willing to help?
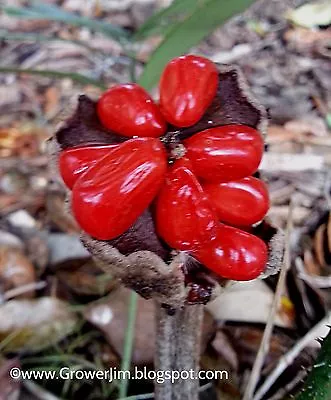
[254,312,331,400]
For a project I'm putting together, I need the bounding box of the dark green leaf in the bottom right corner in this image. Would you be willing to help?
[295,332,331,400]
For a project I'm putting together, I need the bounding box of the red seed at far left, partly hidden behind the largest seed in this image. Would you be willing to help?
[59,144,118,189]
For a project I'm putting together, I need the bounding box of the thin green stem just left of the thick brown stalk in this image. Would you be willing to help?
[119,291,138,399]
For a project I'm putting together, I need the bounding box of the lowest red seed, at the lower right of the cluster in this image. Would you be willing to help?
[192,224,268,281]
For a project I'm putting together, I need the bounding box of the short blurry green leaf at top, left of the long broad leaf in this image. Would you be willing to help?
[134,0,202,40]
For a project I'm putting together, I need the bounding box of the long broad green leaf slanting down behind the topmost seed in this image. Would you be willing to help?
[139,0,254,89]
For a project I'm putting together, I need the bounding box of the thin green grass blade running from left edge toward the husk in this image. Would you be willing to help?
[0,66,107,90]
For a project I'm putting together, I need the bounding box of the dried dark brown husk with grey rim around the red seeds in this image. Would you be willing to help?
[48,65,284,309]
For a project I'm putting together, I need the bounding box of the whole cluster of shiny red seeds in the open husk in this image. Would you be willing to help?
[60,55,269,280]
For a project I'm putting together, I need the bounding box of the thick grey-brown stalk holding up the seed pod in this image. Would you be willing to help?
[155,304,203,400]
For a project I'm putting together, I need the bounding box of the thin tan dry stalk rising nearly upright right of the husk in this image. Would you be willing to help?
[243,201,293,400]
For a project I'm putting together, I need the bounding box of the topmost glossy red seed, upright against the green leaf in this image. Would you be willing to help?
[160,55,218,127]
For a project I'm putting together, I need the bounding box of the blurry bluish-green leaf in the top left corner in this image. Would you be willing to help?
[4,2,129,40]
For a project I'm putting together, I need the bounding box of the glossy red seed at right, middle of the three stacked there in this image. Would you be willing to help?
[203,176,269,226]
